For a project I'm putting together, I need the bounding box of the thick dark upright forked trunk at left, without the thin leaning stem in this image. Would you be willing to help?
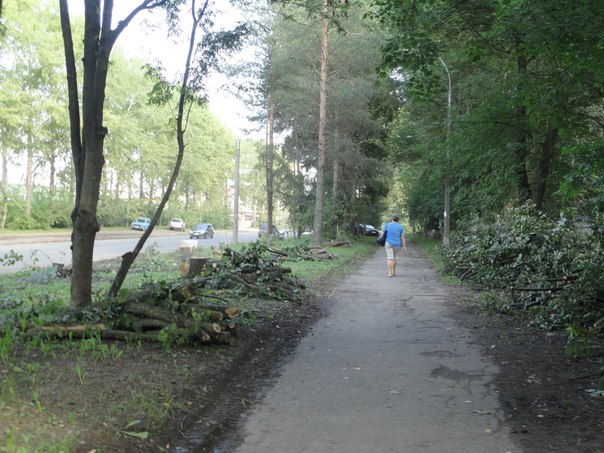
[59,0,124,307]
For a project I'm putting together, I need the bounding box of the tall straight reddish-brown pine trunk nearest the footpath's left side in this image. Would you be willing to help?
[312,0,329,246]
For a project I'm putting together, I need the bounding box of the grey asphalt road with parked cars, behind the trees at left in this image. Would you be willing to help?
[0,228,258,274]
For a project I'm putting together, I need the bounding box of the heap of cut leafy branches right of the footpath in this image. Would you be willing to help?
[443,206,604,330]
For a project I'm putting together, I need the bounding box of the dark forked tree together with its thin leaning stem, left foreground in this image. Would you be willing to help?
[60,0,249,306]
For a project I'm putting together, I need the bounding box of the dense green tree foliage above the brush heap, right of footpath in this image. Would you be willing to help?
[367,0,604,235]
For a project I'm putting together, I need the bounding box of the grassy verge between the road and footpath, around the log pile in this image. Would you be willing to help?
[0,238,375,452]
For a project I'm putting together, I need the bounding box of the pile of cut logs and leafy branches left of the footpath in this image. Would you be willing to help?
[23,242,318,344]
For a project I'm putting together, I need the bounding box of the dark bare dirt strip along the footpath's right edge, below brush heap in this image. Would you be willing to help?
[451,291,604,453]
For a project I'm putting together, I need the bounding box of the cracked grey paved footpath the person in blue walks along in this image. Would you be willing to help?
[229,246,522,453]
